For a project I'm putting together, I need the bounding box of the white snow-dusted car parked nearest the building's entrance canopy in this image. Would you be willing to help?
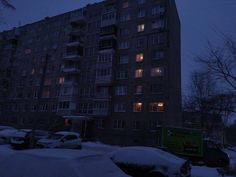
[37,131,82,149]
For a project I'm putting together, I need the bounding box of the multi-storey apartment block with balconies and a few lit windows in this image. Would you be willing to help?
[0,0,181,145]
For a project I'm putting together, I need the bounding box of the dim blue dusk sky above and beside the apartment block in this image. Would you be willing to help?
[0,0,236,94]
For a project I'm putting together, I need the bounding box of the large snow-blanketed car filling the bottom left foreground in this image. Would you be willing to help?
[0,147,130,177]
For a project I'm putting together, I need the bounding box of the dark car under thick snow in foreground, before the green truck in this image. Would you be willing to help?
[110,146,191,177]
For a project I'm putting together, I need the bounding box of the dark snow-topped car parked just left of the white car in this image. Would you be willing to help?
[10,129,48,149]
